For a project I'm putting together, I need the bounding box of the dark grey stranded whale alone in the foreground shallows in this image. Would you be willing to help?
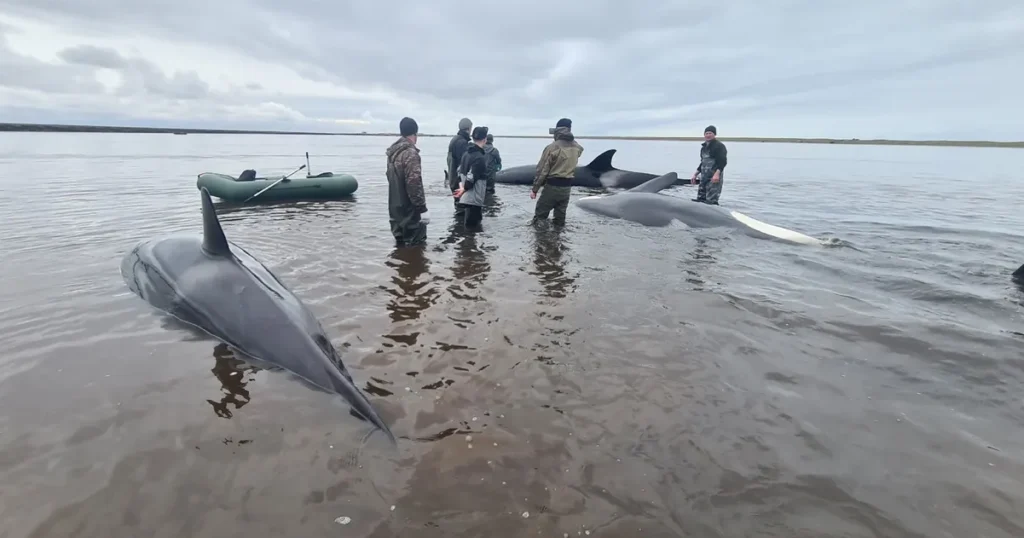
[121,188,394,443]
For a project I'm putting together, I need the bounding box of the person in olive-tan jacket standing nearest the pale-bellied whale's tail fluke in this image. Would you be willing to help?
[529,118,583,224]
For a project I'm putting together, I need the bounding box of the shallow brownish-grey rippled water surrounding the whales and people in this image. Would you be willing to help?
[0,133,1024,538]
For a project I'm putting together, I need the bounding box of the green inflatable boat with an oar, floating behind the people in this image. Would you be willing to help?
[196,170,359,202]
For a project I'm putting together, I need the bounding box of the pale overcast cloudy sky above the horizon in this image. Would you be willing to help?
[0,0,1024,140]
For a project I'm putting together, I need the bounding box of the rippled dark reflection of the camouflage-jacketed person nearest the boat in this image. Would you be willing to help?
[384,245,437,323]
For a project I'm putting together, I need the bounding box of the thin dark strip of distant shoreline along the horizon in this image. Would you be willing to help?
[0,123,1024,149]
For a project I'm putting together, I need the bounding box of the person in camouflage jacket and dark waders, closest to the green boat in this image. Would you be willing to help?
[385,118,427,246]
